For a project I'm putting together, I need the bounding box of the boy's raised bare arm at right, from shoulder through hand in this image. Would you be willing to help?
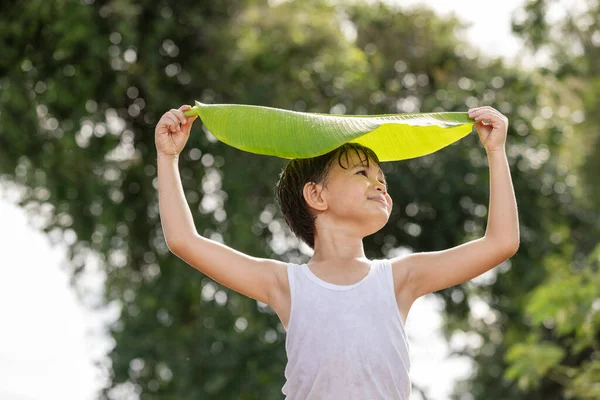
[392,107,519,299]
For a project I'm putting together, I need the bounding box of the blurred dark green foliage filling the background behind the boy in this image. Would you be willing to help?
[0,0,600,400]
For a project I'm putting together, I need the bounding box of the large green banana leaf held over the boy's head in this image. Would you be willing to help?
[184,101,474,162]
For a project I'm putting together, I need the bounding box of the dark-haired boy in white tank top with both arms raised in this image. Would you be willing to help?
[155,105,519,400]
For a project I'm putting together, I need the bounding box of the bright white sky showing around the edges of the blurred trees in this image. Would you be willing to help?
[0,0,522,400]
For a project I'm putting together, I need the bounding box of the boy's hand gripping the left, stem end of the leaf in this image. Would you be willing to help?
[154,105,198,156]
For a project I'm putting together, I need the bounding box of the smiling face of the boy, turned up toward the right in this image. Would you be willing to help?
[312,151,393,237]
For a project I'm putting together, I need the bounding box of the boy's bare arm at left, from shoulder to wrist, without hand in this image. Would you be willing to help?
[157,130,287,307]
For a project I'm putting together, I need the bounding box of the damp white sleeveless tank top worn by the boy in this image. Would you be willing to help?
[281,260,411,400]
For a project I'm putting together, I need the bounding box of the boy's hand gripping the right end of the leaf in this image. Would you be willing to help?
[469,106,508,153]
